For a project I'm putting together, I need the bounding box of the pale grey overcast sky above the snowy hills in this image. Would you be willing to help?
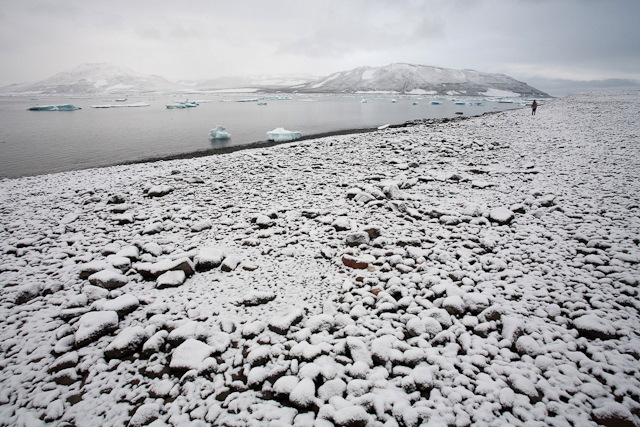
[0,0,640,95]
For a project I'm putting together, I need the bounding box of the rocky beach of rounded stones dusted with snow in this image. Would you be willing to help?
[0,92,640,427]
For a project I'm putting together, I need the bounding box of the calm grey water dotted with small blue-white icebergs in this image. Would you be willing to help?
[0,94,518,178]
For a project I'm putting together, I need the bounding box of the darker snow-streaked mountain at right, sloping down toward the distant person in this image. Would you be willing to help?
[294,64,549,98]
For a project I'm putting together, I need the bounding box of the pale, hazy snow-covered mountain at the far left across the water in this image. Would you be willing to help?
[0,63,184,95]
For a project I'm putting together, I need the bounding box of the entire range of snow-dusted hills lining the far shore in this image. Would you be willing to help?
[0,63,549,98]
